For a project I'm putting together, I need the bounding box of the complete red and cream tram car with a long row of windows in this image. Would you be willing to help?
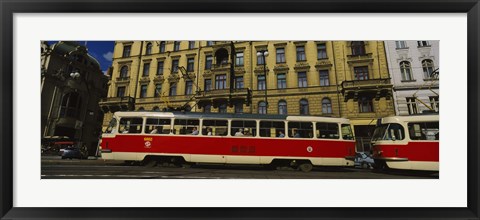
[100,112,355,172]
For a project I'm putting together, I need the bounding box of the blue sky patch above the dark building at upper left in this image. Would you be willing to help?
[48,41,115,73]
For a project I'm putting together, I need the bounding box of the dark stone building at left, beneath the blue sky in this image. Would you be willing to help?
[41,41,108,155]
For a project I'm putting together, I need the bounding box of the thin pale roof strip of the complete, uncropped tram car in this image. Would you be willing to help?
[115,111,349,123]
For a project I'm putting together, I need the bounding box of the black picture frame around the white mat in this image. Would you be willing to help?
[0,0,480,219]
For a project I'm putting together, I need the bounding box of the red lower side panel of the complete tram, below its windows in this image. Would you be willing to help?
[102,134,355,166]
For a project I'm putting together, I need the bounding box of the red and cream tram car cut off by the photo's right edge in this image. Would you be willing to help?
[371,115,439,171]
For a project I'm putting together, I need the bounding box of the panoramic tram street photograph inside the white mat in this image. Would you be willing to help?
[39,39,440,179]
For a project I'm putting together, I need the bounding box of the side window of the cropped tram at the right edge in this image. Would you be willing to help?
[408,122,440,140]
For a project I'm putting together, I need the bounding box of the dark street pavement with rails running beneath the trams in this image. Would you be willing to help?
[41,156,438,179]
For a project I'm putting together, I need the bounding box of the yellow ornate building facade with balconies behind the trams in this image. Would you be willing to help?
[100,41,395,150]
